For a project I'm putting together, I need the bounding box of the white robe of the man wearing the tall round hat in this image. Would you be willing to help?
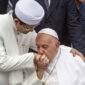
[0,12,37,85]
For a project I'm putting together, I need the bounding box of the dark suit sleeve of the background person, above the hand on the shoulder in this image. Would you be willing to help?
[66,0,85,55]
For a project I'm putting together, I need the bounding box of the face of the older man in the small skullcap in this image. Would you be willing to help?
[36,34,60,61]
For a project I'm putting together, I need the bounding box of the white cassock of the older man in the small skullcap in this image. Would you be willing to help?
[24,46,85,85]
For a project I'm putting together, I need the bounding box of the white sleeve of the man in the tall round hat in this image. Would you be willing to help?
[0,38,34,72]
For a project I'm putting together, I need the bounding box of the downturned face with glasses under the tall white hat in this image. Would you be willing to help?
[14,19,38,34]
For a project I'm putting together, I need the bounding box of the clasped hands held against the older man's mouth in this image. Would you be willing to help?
[34,54,49,79]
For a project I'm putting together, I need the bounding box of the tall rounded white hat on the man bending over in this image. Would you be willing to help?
[15,0,44,25]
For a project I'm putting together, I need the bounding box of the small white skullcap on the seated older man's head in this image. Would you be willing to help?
[38,28,58,39]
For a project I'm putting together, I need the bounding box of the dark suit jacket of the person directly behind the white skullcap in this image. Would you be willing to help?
[36,0,85,54]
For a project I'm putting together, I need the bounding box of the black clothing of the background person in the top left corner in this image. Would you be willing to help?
[0,0,8,14]
